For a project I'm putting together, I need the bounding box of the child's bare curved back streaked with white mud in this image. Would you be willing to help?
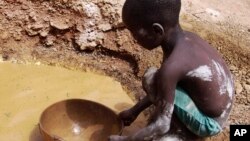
[171,32,234,117]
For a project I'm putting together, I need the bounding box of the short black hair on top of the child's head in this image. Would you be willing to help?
[122,0,181,27]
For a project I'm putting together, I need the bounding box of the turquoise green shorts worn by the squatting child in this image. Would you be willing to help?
[174,87,222,137]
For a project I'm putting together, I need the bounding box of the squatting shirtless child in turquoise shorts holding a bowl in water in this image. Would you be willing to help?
[109,0,234,141]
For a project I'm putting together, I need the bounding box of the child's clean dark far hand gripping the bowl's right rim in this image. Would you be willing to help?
[119,110,137,126]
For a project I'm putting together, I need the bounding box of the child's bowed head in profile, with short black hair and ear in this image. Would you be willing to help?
[122,0,181,49]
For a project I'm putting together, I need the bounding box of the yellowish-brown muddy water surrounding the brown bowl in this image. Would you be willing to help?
[0,62,145,141]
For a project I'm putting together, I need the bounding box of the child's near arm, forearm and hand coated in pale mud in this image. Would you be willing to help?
[110,65,179,141]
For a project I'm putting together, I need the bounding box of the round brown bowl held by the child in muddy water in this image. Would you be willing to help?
[39,99,123,141]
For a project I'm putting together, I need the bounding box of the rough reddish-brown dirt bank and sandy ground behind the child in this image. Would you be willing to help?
[0,0,250,141]
